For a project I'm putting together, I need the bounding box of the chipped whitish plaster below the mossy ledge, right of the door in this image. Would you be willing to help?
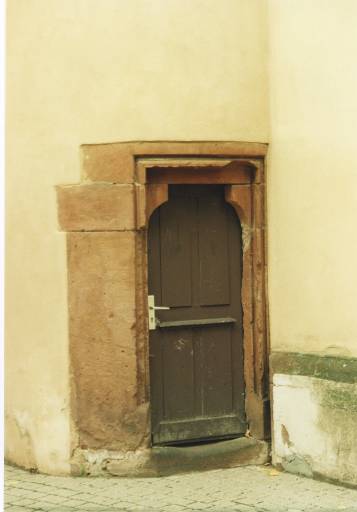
[273,374,357,484]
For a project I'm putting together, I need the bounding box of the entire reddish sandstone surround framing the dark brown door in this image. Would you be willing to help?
[57,142,269,456]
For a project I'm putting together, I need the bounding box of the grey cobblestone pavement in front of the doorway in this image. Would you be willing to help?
[5,466,357,512]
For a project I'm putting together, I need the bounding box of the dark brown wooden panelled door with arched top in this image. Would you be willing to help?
[148,185,246,444]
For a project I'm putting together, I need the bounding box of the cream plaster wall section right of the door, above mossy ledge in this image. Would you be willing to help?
[268,0,357,356]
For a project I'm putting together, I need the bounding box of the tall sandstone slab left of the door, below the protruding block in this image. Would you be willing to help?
[68,232,147,450]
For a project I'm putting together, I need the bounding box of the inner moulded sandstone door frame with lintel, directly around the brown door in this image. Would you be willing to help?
[136,157,270,439]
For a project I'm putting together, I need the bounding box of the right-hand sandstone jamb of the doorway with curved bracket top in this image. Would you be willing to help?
[225,185,270,439]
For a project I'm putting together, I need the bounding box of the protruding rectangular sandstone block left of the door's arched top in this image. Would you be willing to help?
[57,183,135,231]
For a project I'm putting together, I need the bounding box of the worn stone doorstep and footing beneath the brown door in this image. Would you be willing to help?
[71,437,270,477]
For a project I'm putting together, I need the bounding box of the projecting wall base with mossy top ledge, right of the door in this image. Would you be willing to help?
[271,353,357,486]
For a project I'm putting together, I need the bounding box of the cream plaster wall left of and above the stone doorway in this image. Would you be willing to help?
[6,0,268,473]
